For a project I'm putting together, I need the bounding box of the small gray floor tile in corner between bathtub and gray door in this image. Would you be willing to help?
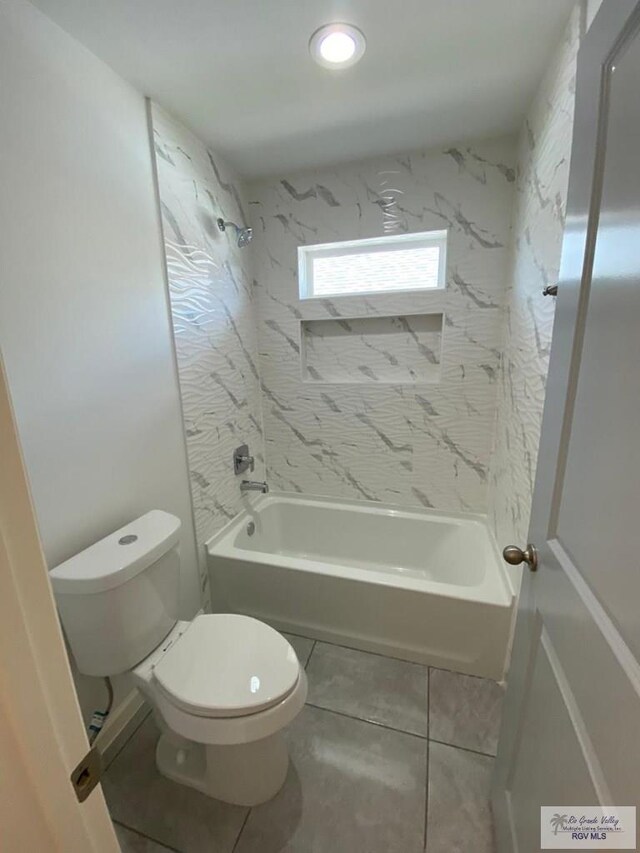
[429,669,504,755]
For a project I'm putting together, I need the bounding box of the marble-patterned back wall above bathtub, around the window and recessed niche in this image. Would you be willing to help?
[247,138,515,512]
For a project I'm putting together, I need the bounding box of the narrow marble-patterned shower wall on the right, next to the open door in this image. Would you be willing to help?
[489,3,583,544]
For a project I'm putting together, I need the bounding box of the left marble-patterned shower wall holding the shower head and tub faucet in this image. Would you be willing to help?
[152,104,265,605]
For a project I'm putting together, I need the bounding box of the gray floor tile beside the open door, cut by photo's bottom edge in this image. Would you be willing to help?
[427,742,495,853]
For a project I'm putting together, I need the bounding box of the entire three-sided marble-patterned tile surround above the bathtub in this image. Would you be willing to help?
[152,7,582,564]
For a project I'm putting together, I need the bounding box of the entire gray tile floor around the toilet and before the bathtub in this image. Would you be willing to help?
[103,635,502,853]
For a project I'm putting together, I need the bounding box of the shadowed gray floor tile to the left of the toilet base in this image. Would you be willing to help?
[103,717,247,853]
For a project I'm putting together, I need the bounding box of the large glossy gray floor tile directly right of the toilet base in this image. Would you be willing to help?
[236,707,427,853]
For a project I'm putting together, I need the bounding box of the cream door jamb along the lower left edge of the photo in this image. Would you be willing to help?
[0,358,120,853]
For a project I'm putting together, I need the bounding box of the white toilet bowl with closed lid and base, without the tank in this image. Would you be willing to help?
[132,614,307,806]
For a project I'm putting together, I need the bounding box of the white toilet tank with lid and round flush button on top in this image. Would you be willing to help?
[49,509,181,676]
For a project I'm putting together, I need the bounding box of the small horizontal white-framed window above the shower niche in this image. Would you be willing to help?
[298,231,447,299]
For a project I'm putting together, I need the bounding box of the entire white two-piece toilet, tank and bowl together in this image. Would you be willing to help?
[51,510,307,806]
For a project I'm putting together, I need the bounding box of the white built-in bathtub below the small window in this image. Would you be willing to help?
[207,493,514,680]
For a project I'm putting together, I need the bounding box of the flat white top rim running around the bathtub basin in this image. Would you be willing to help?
[205,491,516,609]
